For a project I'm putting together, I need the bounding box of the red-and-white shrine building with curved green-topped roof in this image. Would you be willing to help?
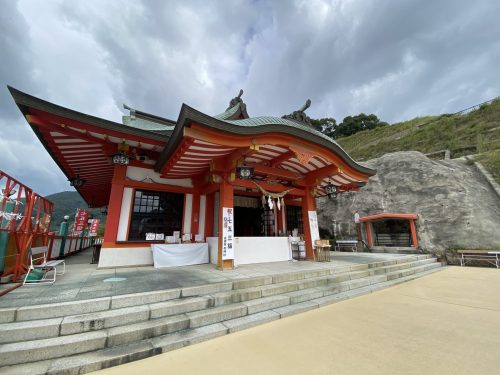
[9,87,375,269]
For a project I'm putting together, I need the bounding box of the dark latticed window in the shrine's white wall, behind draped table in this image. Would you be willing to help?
[128,190,184,241]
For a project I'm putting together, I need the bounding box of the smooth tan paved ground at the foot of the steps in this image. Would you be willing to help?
[96,267,500,375]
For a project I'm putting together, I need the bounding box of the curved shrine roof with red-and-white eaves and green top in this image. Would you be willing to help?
[9,87,375,206]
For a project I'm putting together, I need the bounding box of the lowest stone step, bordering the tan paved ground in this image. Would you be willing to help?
[0,263,442,375]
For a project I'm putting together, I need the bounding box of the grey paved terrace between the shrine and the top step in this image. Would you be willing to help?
[0,249,404,308]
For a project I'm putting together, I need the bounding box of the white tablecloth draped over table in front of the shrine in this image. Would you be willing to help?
[151,243,208,268]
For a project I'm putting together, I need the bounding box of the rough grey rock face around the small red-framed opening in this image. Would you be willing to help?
[317,152,500,252]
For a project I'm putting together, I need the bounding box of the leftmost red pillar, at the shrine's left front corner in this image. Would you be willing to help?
[102,165,127,248]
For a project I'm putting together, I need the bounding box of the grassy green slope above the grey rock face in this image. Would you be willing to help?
[337,99,500,183]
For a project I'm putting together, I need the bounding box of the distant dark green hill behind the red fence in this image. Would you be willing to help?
[45,191,106,231]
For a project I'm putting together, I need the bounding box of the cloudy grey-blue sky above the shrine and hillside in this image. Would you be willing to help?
[0,0,500,195]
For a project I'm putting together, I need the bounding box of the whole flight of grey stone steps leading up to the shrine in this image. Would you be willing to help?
[0,255,441,375]
